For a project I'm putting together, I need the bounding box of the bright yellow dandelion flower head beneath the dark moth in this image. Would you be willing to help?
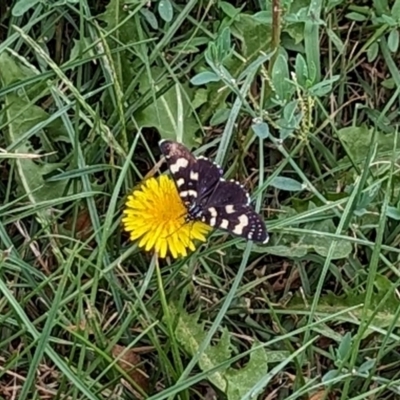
[122,175,211,258]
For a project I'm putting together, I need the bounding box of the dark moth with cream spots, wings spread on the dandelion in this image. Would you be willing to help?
[159,139,269,243]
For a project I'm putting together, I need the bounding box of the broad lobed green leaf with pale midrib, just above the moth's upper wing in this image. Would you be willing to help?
[135,67,198,148]
